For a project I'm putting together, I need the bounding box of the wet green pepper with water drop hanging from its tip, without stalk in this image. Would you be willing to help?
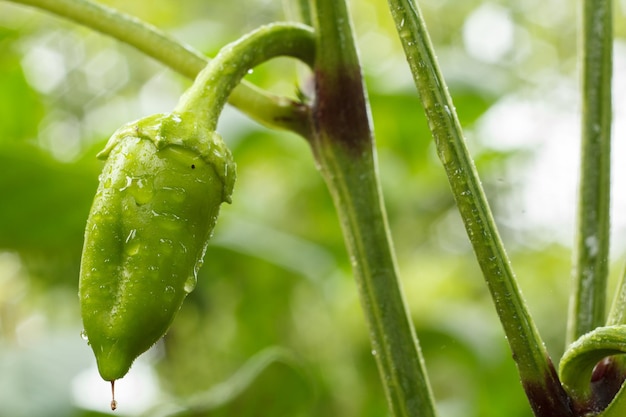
[79,113,235,381]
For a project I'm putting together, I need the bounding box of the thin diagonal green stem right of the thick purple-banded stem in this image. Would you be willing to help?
[382,0,572,416]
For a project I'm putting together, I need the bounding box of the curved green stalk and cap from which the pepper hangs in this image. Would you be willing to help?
[144,23,315,195]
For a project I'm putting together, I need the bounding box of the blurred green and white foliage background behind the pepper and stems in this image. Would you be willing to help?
[0,0,626,417]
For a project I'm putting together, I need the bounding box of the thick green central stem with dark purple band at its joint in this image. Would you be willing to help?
[311,0,436,417]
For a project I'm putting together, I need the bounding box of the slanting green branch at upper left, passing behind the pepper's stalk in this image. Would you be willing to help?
[9,0,313,137]
